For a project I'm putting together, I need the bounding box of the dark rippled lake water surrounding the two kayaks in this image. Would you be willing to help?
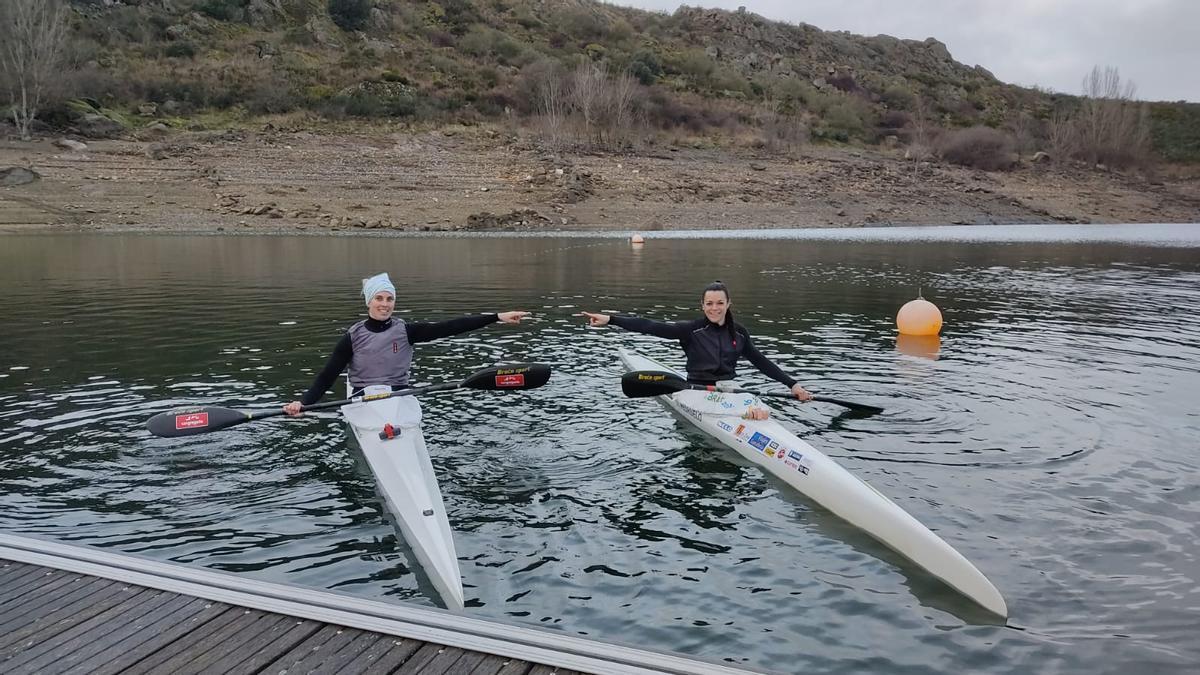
[0,226,1200,673]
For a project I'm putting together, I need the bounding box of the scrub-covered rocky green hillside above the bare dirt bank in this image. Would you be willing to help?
[16,0,1200,161]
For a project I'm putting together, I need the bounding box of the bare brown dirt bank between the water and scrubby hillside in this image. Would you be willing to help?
[0,127,1200,233]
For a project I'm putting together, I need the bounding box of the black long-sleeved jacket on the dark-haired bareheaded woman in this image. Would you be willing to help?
[608,315,796,389]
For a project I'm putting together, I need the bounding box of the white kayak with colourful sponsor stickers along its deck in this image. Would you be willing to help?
[620,350,1008,617]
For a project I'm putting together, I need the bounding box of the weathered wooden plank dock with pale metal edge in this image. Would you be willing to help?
[0,533,763,675]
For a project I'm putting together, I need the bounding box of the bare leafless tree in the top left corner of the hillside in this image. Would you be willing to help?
[0,0,67,141]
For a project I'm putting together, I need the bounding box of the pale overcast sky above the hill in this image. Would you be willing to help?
[606,0,1200,102]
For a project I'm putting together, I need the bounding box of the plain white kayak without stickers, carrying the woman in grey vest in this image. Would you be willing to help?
[342,387,463,609]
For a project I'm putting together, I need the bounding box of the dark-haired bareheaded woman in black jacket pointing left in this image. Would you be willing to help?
[581,281,812,419]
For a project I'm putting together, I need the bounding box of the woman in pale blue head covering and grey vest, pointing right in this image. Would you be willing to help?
[283,273,529,416]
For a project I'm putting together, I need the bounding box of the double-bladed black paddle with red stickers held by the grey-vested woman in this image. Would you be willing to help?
[146,363,550,437]
